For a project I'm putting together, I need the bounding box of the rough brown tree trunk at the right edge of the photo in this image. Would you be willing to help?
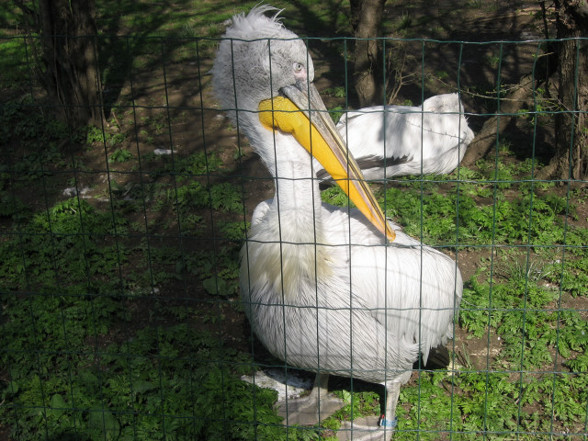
[539,0,588,180]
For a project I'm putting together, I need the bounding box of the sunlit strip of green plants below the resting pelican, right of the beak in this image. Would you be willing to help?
[368,165,587,252]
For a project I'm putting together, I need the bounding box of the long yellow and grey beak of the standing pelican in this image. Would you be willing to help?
[259,83,396,242]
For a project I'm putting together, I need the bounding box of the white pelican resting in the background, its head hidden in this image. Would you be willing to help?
[318,93,474,179]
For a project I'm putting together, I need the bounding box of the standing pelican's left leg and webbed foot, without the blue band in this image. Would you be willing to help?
[276,374,345,426]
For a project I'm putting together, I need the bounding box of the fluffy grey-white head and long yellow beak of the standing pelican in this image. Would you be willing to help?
[212,5,395,240]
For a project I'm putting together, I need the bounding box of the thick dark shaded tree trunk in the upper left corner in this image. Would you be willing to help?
[39,0,103,128]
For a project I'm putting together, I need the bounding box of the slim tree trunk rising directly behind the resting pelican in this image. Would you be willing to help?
[351,0,386,107]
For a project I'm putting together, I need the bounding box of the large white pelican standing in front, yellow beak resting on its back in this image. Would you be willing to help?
[211,6,462,439]
